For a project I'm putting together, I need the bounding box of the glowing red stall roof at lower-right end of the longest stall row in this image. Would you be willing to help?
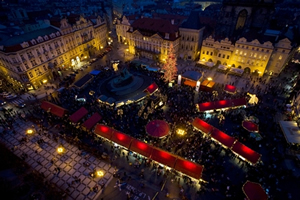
[175,157,203,179]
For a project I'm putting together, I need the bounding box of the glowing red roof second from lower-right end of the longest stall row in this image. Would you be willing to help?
[151,147,176,168]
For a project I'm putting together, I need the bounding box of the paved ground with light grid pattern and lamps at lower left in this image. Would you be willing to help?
[0,119,115,200]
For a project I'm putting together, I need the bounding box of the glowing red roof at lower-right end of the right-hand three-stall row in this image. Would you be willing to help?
[231,141,261,165]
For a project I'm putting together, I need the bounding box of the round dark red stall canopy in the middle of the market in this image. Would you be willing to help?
[146,120,170,138]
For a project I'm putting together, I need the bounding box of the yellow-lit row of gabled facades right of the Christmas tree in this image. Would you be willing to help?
[200,36,292,75]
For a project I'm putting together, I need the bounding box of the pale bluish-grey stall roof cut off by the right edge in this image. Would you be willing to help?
[279,121,300,144]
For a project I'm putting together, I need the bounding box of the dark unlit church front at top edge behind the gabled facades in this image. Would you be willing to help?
[216,0,275,38]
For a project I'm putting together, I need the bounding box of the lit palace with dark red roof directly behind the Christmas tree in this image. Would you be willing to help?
[123,18,180,62]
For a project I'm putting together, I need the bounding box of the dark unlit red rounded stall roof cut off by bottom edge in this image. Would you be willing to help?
[242,181,268,200]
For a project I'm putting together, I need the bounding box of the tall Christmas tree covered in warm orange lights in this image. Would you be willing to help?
[162,44,177,82]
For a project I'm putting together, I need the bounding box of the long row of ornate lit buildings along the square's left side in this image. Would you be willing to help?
[0,15,107,90]
